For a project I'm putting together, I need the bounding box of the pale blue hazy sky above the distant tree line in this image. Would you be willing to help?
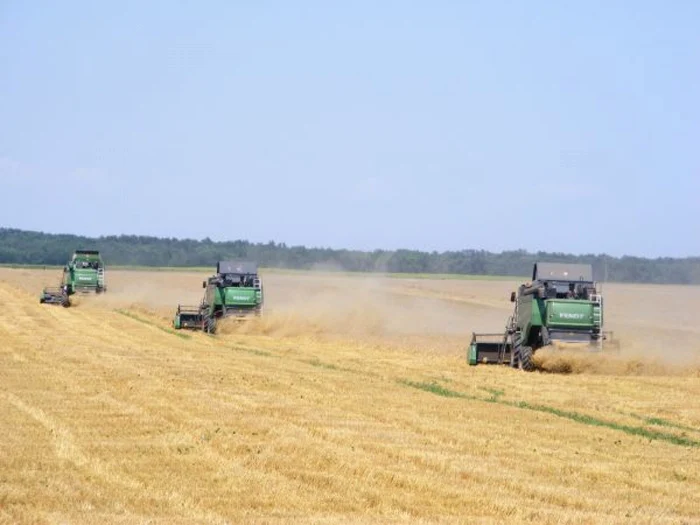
[0,0,700,257]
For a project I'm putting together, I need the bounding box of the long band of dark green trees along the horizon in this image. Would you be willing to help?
[0,228,700,284]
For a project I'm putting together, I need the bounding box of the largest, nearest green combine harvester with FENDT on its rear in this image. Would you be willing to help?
[467,262,612,370]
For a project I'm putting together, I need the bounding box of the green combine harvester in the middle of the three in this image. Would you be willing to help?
[173,261,264,334]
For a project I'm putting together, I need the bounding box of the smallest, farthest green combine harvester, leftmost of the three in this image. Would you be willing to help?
[39,250,107,307]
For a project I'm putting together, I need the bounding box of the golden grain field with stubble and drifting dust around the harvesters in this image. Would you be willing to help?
[0,269,700,525]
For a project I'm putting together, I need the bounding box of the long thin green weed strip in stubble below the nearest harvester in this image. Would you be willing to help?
[399,380,700,447]
